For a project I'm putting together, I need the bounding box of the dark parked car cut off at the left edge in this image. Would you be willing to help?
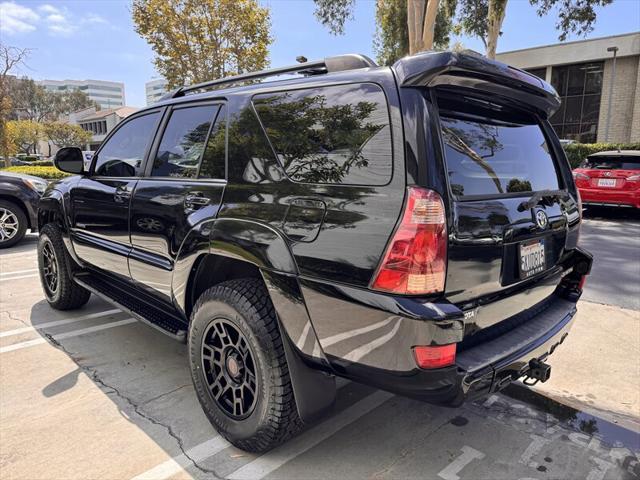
[0,170,47,248]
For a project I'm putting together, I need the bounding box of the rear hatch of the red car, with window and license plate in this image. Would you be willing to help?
[574,152,640,191]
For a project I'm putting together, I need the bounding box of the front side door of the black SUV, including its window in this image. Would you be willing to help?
[70,110,161,278]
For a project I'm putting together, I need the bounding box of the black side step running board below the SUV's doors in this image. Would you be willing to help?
[73,273,187,343]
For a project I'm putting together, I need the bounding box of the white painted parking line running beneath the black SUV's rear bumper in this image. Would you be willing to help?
[227,390,393,480]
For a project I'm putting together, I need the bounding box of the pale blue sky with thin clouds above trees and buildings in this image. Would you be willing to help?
[0,0,640,107]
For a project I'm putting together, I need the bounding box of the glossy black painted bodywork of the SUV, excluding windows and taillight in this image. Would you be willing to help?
[37,53,591,412]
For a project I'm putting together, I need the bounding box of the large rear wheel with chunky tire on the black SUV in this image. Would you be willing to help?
[189,278,302,452]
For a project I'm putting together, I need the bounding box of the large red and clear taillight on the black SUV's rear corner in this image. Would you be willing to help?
[371,187,447,295]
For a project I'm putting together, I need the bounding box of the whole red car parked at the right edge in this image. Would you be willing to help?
[573,150,640,208]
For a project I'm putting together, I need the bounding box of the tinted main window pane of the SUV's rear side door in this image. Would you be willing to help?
[151,105,220,178]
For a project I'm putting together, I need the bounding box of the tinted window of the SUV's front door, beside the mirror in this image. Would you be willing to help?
[94,112,160,177]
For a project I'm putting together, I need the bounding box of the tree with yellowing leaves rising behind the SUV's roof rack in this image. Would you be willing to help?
[132,0,273,88]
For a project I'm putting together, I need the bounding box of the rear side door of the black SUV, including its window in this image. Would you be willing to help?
[129,103,226,302]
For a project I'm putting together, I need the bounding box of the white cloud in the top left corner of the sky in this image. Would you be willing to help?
[0,1,109,37]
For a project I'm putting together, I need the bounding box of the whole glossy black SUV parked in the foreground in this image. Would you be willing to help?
[38,52,591,451]
